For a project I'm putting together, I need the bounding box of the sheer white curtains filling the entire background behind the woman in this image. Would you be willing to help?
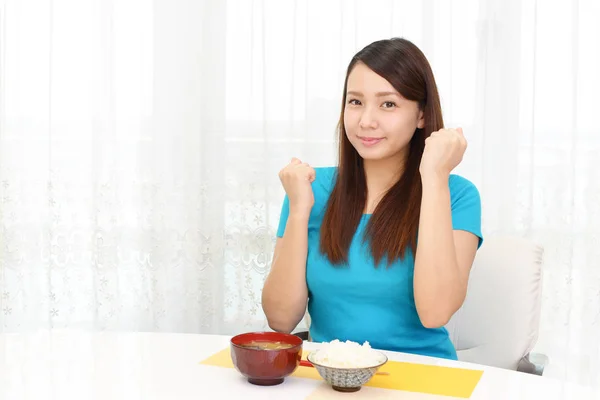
[0,0,600,383]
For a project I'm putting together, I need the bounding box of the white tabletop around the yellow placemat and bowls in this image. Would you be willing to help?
[0,332,600,400]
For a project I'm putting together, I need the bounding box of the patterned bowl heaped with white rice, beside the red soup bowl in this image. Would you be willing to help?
[307,339,388,392]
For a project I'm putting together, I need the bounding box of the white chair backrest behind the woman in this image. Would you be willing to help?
[446,236,543,370]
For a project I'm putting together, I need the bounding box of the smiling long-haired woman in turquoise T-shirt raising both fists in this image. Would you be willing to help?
[262,39,483,359]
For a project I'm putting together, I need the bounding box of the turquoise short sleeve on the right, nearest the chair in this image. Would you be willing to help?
[450,175,483,248]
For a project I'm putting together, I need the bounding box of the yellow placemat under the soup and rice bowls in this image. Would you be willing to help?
[200,348,483,399]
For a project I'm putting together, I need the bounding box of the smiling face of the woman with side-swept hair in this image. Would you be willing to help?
[344,62,425,160]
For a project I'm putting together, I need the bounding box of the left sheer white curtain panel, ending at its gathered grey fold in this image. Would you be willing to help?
[0,0,226,332]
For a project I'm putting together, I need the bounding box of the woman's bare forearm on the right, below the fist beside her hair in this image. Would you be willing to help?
[413,175,467,327]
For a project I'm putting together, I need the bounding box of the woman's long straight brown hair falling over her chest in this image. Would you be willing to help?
[320,38,444,266]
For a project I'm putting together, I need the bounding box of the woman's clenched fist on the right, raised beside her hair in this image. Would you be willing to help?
[419,128,467,177]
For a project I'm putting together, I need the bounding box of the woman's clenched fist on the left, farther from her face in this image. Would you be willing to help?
[279,158,315,216]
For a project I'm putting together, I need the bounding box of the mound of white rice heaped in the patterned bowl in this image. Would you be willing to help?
[311,339,384,368]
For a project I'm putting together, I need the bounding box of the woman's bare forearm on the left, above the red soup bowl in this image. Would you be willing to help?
[262,214,308,333]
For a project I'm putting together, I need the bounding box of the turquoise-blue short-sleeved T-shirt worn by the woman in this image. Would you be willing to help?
[277,167,483,360]
